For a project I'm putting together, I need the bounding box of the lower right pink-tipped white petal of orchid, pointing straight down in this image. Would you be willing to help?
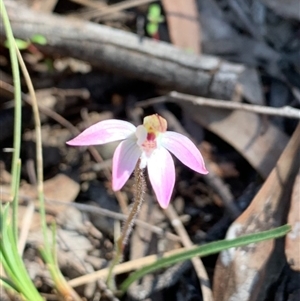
[148,147,175,209]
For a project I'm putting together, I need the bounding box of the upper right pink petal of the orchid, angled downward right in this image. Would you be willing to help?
[161,131,208,174]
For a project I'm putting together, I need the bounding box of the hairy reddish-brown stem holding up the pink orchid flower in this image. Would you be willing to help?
[107,162,146,290]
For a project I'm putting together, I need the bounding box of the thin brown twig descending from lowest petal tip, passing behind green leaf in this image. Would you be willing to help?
[164,204,213,301]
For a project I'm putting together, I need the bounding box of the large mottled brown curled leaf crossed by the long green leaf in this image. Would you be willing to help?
[214,125,300,301]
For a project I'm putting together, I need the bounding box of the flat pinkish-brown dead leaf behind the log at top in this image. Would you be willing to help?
[162,0,201,54]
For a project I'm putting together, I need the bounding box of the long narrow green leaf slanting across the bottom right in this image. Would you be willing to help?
[121,225,291,293]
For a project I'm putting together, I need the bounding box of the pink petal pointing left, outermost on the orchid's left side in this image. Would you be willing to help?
[67,119,136,145]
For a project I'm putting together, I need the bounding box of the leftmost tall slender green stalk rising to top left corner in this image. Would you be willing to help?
[0,0,22,243]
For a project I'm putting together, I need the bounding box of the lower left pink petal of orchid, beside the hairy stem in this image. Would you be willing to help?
[112,139,142,191]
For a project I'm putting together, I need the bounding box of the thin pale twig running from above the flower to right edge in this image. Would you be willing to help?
[137,91,300,119]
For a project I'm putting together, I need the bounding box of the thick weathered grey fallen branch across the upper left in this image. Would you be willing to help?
[0,1,246,99]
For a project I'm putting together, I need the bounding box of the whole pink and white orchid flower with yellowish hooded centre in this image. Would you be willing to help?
[67,114,208,209]
